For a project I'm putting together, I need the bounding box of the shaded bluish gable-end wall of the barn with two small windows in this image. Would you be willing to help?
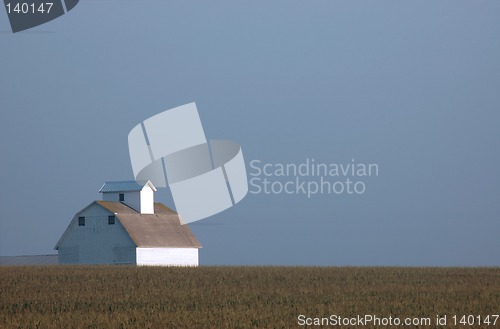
[58,204,135,264]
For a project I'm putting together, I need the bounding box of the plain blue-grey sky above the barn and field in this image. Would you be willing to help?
[0,1,500,266]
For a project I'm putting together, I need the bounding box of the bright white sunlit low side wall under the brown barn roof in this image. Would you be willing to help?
[136,248,198,266]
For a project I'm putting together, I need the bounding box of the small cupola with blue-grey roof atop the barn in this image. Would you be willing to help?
[99,180,156,214]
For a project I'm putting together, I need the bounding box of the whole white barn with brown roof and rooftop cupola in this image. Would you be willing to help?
[55,181,201,266]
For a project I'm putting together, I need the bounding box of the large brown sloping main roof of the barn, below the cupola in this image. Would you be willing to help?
[96,201,201,248]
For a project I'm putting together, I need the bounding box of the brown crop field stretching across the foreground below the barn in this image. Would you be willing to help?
[0,266,500,328]
